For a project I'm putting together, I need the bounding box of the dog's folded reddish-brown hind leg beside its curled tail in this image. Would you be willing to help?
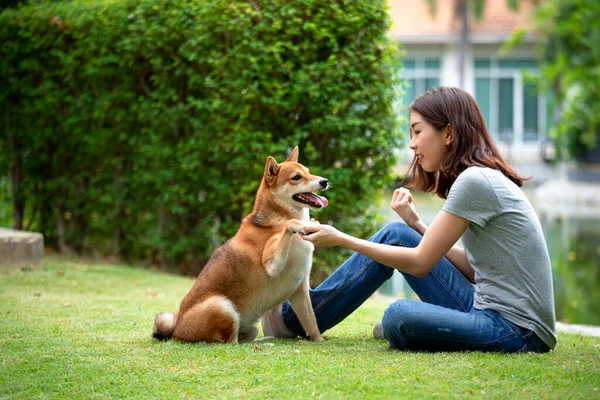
[173,296,240,343]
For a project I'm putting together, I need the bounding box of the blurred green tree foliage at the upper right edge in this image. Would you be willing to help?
[535,0,600,158]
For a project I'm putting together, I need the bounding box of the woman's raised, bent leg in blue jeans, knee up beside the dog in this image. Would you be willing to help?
[281,222,473,336]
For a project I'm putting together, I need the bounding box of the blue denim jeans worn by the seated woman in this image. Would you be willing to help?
[282,222,550,353]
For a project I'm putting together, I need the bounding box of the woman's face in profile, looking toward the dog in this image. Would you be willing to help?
[408,111,451,172]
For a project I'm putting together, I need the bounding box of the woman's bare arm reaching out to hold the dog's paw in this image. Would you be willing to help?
[303,211,469,277]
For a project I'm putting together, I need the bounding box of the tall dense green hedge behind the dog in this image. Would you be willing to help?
[0,0,402,276]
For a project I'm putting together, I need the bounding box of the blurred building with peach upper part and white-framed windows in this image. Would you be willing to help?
[389,0,552,171]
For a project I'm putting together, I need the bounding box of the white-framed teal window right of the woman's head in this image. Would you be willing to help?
[475,57,548,144]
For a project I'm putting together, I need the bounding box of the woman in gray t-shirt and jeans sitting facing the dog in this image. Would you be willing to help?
[262,87,556,352]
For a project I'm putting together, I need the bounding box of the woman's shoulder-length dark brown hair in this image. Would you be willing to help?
[406,86,529,199]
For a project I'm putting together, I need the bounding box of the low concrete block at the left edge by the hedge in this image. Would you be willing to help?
[0,228,44,268]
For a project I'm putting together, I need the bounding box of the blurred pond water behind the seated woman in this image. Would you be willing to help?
[380,191,600,325]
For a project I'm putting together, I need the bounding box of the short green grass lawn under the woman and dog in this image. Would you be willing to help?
[0,259,600,399]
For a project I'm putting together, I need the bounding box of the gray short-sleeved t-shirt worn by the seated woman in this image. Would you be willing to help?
[442,167,556,348]
